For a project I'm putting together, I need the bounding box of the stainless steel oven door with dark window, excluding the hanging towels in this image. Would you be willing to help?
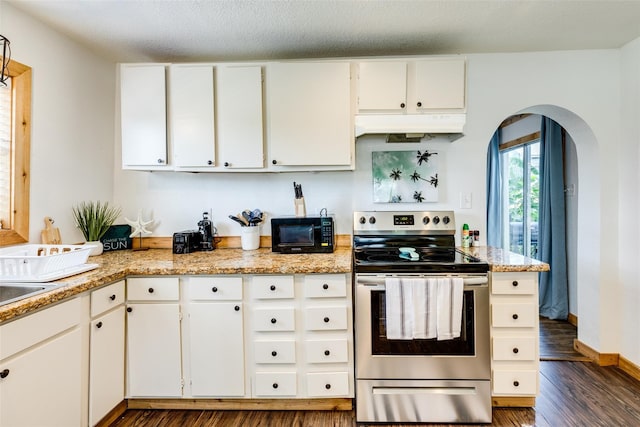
[354,274,491,380]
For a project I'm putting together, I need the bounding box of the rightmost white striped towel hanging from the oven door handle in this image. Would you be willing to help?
[437,277,464,340]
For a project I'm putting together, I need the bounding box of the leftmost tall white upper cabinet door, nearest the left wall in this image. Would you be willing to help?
[120,64,167,169]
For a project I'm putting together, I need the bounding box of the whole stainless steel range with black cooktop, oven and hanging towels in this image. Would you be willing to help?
[353,211,491,423]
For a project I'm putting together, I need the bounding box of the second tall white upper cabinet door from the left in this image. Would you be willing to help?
[169,65,216,167]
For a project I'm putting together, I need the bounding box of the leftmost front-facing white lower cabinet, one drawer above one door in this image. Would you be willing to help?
[127,277,182,397]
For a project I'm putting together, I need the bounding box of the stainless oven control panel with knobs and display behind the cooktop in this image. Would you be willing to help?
[353,211,456,234]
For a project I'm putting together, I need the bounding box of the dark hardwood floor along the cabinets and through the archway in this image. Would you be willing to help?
[111,318,640,427]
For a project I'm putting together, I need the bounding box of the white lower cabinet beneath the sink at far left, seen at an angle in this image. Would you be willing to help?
[0,298,86,427]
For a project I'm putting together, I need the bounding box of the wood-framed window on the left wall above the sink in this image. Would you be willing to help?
[0,60,31,246]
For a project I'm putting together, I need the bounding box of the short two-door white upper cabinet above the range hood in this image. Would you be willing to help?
[358,57,466,114]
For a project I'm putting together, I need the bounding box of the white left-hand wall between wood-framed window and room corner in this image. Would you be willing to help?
[0,2,115,243]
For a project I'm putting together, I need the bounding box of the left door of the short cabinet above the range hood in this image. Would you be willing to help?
[358,61,407,113]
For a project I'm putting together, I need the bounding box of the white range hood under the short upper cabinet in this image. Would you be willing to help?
[355,113,466,142]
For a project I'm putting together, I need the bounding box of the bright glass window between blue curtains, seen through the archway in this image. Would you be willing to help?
[500,140,540,258]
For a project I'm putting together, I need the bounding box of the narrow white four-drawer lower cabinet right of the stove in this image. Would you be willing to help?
[490,272,539,397]
